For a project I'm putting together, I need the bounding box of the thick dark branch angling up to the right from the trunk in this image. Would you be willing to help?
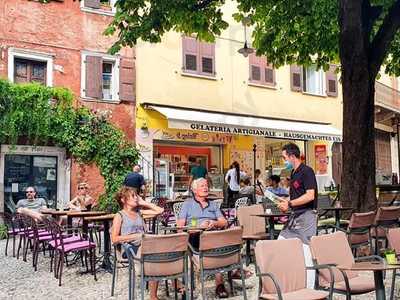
[370,0,400,75]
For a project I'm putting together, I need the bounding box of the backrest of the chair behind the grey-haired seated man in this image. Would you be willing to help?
[199,226,243,269]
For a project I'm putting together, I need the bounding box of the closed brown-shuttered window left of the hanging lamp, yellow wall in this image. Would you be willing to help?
[182,37,215,77]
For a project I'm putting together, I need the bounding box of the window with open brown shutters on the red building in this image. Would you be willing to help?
[81,53,135,102]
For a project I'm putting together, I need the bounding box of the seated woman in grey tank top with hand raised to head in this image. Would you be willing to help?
[111,186,164,300]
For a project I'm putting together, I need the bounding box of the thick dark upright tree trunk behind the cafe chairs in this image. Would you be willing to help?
[339,0,376,211]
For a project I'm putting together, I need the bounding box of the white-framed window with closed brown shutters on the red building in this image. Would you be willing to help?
[8,48,53,86]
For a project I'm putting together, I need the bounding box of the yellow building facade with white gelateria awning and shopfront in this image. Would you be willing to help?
[136,2,354,197]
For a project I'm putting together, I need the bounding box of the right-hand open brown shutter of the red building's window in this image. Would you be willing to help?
[119,58,135,102]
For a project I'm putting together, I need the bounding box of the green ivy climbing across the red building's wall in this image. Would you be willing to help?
[0,79,138,211]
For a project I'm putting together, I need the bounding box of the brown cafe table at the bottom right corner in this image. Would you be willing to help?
[336,261,400,300]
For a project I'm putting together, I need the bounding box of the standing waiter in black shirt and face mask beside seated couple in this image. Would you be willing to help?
[278,143,318,288]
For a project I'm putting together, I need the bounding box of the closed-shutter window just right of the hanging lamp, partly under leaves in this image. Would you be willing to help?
[249,53,276,86]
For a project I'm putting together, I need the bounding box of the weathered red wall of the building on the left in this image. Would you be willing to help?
[0,0,135,203]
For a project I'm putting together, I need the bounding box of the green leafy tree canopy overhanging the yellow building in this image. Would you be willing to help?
[106,0,400,76]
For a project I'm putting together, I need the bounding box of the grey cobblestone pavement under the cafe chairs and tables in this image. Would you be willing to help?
[0,240,400,300]
